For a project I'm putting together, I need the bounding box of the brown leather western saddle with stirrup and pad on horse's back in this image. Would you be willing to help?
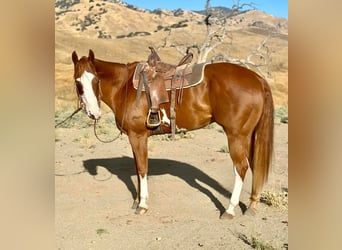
[133,47,205,137]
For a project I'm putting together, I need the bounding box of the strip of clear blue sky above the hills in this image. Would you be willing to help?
[123,0,288,18]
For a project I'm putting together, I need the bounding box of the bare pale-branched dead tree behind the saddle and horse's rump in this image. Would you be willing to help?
[161,0,272,77]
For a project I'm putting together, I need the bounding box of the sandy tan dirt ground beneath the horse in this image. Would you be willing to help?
[55,117,288,250]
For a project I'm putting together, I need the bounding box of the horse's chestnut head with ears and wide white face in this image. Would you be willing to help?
[72,50,101,120]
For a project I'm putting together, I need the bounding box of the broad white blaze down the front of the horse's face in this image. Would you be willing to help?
[77,71,101,119]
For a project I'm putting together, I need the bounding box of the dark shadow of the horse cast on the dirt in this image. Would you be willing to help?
[83,157,247,214]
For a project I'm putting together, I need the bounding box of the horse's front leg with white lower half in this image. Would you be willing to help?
[128,133,148,214]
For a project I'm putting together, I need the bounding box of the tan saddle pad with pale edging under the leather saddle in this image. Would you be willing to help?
[133,62,207,90]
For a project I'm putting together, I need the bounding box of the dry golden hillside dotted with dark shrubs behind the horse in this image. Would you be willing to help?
[55,0,288,106]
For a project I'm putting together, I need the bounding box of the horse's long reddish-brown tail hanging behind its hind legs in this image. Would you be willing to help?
[250,80,274,193]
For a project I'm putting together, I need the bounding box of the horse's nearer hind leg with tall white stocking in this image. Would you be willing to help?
[220,135,249,219]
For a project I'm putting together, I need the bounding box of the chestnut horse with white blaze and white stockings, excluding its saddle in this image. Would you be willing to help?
[72,50,274,219]
